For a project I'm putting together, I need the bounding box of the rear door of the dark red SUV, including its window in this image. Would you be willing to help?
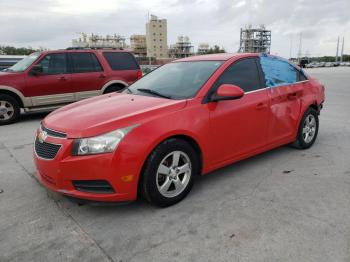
[69,52,106,100]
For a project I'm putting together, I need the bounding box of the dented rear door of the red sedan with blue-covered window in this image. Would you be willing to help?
[260,55,304,143]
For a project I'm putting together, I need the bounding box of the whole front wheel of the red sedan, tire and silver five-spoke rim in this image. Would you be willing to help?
[141,138,199,207]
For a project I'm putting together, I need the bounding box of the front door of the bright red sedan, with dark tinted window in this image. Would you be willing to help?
[208,58,269,165]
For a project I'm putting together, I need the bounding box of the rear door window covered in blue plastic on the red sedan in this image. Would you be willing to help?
[260,55,299,87]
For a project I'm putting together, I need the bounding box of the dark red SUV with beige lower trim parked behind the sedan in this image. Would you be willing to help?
[0,49,142,125]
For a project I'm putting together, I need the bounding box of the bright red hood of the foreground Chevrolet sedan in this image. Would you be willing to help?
[43,93,186,138]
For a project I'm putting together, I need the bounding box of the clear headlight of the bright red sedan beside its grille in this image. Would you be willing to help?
[72,125,137,156]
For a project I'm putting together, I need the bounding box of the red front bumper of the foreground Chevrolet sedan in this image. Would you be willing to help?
[33,130,141,202]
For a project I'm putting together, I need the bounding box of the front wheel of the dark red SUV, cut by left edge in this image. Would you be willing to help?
[0,94,21,125]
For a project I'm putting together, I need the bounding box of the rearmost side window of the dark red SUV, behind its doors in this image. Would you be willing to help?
[103,52,139,70]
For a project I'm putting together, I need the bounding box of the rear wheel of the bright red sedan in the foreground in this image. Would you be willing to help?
[292,107,319,149]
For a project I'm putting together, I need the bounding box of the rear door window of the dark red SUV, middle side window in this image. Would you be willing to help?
[70,53,102,73]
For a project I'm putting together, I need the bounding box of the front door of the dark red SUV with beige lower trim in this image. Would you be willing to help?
[26,53,74,106]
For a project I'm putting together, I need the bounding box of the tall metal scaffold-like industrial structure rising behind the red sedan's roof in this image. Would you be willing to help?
[238,25,271,54]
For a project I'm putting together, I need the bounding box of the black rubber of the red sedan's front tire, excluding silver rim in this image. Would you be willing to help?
[140,138,199,207]
